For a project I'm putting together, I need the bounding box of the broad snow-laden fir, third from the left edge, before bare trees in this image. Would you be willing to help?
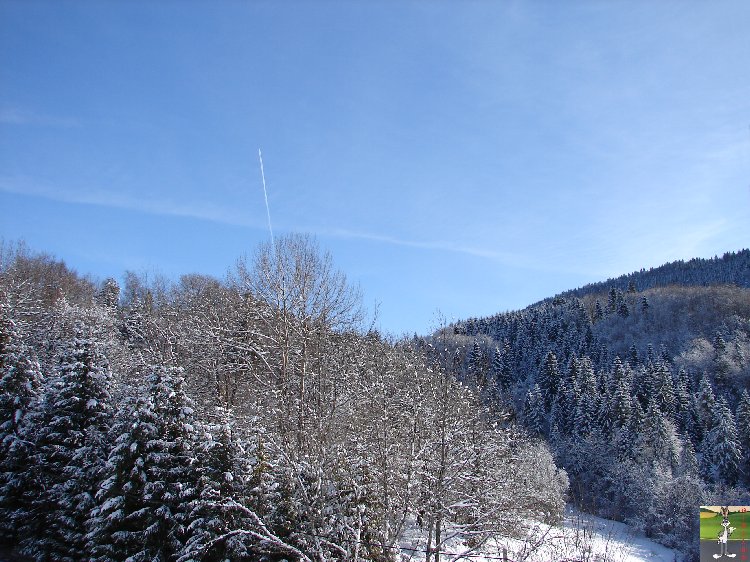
[88,367,199,560]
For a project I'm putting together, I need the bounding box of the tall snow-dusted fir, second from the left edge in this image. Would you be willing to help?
[20,321,111,561]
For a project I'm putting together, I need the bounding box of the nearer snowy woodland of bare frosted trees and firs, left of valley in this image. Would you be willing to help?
[0,235,568,561]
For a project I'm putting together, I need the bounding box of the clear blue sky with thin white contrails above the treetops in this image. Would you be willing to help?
[0,0,750,334]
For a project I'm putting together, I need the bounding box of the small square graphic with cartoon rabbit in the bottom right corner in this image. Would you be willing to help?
[700,505,750,562]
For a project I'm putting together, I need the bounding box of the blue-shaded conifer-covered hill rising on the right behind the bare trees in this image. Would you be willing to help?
[440,250,750,547]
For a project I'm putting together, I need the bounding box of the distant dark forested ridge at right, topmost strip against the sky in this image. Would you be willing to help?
[560,249,750,297]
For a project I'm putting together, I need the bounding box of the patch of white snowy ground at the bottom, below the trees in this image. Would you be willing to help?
[401,507,679,562]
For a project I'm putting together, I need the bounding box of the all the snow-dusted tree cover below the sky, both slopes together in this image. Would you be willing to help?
[0,235,750,562]
